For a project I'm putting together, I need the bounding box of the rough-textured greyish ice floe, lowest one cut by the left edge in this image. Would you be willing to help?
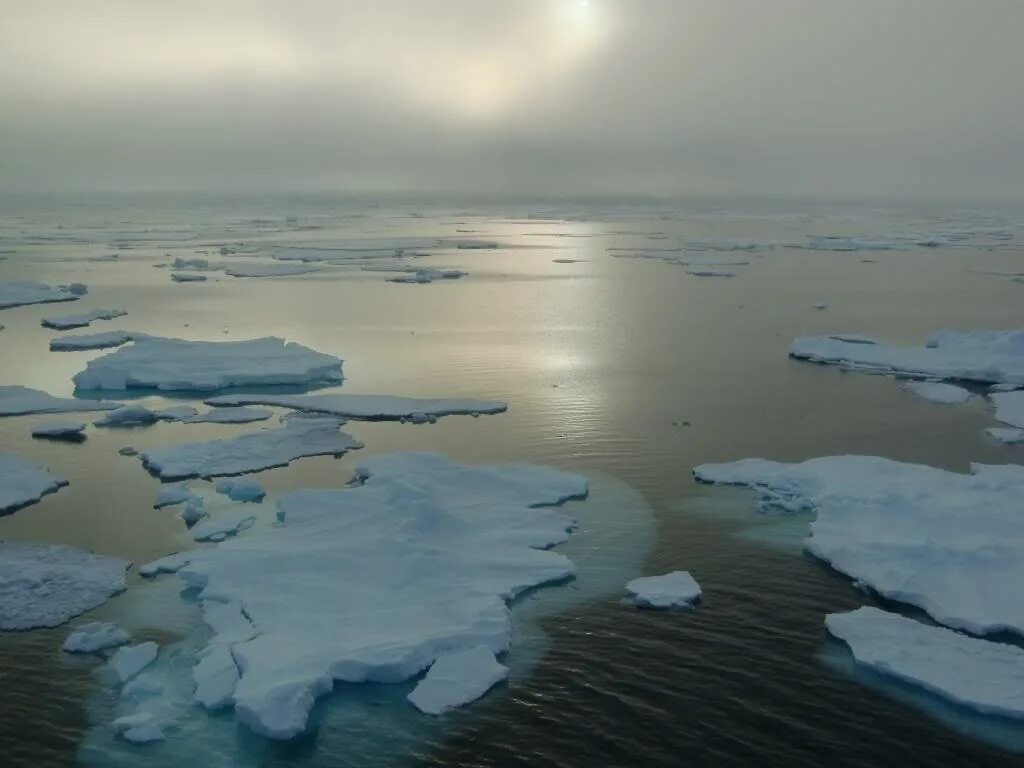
[0,542,130,630]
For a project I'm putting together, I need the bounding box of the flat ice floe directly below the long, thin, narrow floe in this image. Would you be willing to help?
[141,419,362,480]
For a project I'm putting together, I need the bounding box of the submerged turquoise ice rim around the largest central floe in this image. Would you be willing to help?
[71,475,655,768]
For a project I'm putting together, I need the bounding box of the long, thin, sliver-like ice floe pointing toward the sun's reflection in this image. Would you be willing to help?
[206,394,508,420]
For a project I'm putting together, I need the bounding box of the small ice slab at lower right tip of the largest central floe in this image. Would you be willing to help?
[409,645,509,715]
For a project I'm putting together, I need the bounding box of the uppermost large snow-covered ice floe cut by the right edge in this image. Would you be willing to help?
[790,329,1024,384]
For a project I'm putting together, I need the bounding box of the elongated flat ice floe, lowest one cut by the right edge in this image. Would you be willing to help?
[825,607,1024,718]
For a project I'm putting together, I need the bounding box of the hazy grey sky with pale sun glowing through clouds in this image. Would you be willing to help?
[0,0,1024,197]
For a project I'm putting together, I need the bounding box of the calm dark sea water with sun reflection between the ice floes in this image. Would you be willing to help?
[0,198,1024,766]
